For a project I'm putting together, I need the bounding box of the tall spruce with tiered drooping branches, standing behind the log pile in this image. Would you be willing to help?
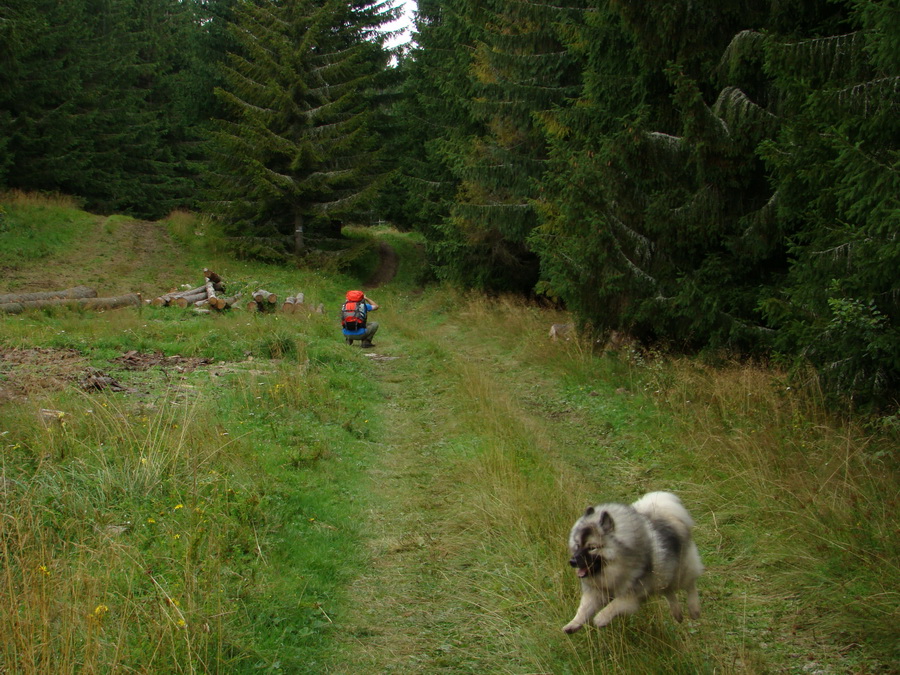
[209,0,392,254]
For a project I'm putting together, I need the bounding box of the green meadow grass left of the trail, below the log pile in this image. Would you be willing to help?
[0,317,380,672]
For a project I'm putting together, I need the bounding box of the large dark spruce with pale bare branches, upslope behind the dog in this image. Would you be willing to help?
[534,2,796,348]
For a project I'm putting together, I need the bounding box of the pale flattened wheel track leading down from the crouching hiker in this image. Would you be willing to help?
[329,346,512,673]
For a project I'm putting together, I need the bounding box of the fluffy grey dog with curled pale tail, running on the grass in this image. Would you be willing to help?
[563,492,703,633]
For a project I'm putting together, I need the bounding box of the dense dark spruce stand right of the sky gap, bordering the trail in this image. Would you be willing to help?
[390,0,900,404]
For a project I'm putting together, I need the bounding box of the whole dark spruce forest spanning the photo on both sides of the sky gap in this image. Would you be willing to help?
[0,0,900,405]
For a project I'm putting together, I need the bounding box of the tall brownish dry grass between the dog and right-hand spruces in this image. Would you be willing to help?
[660,361,900,659]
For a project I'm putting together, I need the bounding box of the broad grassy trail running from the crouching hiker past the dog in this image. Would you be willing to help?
[320,290,896,675]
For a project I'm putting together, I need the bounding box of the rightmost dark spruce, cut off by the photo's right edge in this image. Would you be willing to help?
[752,0,900,408]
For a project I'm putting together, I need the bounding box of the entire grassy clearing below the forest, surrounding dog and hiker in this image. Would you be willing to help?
[0,197,900,673]
